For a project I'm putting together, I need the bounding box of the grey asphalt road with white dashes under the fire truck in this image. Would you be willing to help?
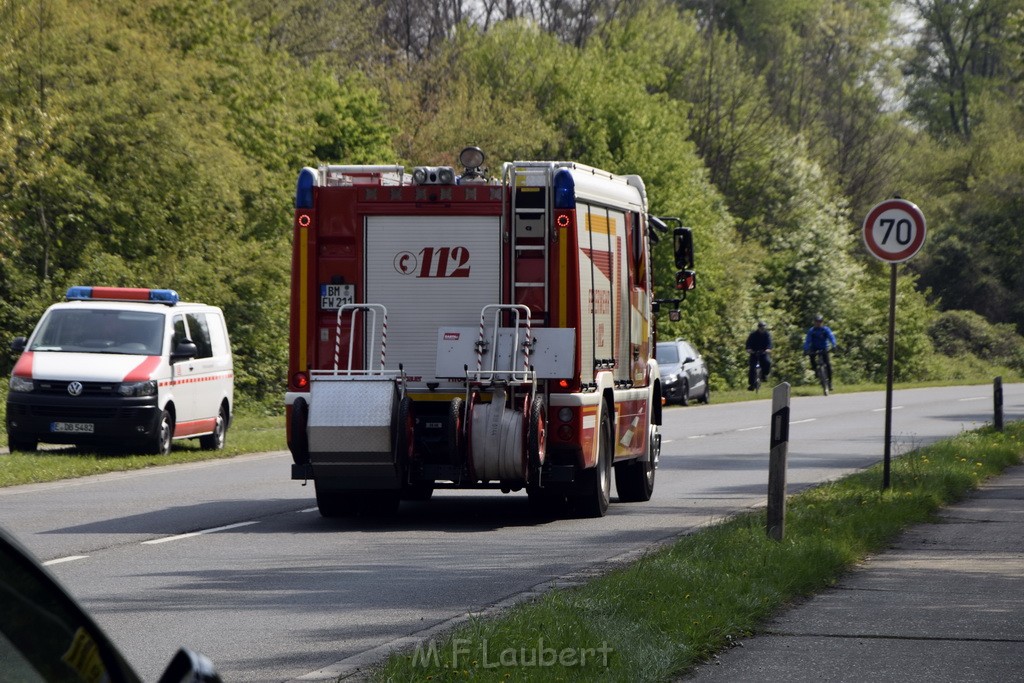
[0,384,1024,681]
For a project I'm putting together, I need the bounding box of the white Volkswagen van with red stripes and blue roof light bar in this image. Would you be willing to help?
[7,287,234,454]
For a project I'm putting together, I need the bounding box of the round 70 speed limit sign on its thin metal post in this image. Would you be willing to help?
[863,197,927,489]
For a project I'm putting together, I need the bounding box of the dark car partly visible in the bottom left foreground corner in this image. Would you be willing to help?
[0,528,220,683]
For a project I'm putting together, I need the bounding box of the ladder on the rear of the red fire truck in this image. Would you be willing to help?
[502,162,557,327]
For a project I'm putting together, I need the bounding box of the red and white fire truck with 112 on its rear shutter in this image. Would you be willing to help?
[285,147,694,517]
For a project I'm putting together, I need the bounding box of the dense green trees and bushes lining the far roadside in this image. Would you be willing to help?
[0,0,1024,401]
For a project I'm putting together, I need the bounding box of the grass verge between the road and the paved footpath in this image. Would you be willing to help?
[373,422,1024,681]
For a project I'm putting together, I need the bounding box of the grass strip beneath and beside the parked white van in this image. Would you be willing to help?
[0,413,287,486]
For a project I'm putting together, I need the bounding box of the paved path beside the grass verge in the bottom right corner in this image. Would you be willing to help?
[682,466,1024,683]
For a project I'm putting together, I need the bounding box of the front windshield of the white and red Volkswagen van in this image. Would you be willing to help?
[29,308,164,355]
